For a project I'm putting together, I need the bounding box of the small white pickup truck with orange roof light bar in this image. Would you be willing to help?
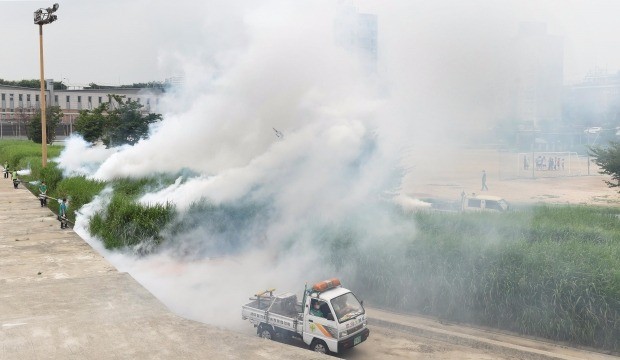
[241,278,370,353]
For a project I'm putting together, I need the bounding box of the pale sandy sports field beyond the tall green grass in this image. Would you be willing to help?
[401,149,620,205]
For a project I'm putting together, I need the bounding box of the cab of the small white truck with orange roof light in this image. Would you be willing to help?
[302,279,370,353]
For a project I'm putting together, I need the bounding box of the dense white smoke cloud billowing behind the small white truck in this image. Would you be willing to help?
[59,2,397,328]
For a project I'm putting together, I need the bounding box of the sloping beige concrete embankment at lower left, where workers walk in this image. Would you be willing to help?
[0,178,326,360]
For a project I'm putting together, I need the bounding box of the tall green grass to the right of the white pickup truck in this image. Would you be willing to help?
[329,206,620,351]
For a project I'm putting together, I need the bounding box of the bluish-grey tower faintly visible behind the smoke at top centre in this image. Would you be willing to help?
[334,5,378,73]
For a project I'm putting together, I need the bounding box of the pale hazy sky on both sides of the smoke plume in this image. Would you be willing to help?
[0,0,620,85]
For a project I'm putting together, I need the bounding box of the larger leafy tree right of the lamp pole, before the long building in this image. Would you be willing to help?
[73,95,162,147]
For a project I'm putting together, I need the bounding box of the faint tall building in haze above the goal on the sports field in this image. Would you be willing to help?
[511,22,564,130]
